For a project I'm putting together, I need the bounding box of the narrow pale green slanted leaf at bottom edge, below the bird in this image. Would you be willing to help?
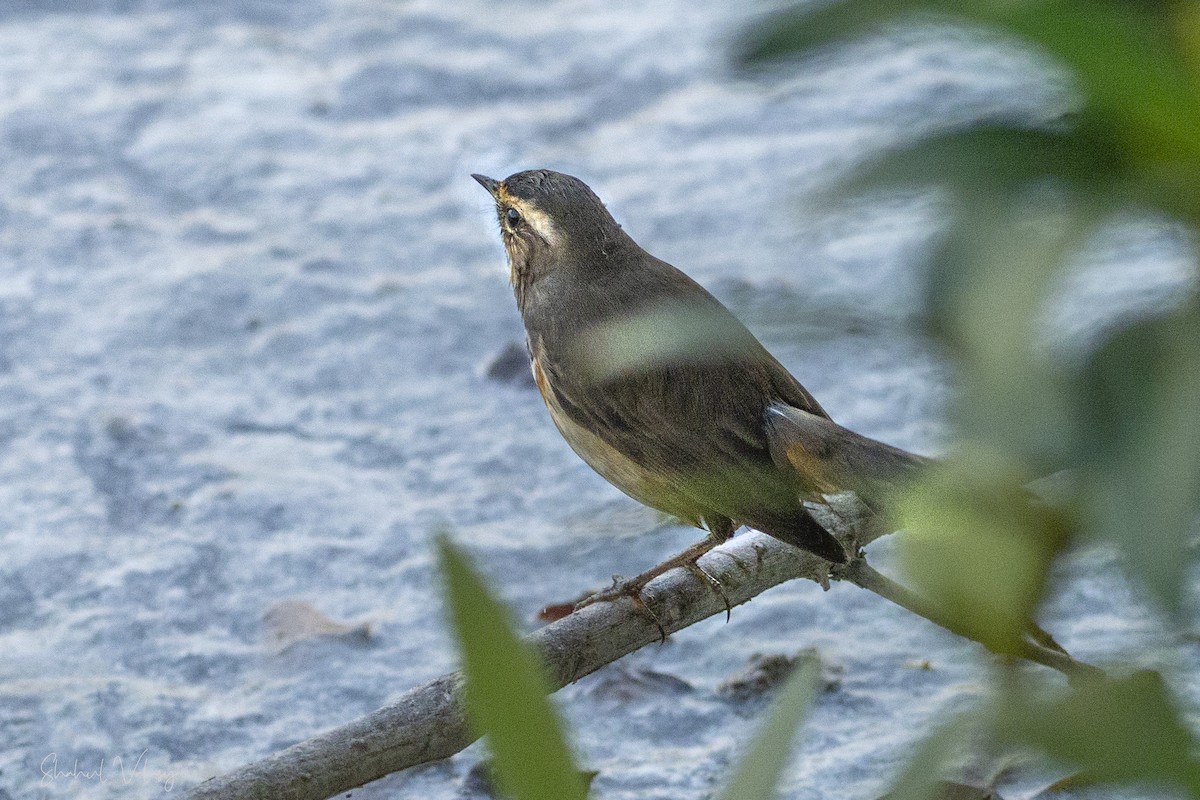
[718,658,821,800]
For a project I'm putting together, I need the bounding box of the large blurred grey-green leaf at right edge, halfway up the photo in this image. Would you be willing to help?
[1075,302,1200,612]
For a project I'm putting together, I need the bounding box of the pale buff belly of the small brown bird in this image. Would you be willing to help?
[532,347,701,528]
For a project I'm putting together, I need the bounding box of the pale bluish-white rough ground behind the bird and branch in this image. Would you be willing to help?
[0,0,1200,800]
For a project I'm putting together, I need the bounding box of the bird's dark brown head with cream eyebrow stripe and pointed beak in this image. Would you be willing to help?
[472,169,631,300]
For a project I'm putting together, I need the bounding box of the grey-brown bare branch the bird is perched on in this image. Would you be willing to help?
[185,509,1094,800]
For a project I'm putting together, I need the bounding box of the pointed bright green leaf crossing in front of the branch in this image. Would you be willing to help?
[437,536,587,800]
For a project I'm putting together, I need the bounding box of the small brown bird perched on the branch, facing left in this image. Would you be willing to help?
[473,169,924,594]
